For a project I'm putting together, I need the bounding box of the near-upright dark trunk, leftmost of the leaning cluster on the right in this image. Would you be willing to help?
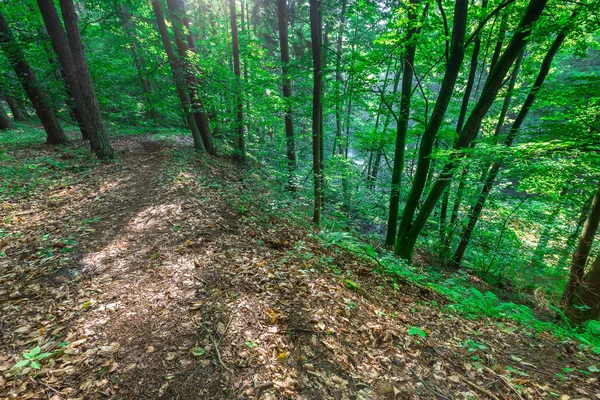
[385,0,422,247]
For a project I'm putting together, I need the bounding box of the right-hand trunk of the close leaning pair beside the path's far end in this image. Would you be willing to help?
[167,0,215,154]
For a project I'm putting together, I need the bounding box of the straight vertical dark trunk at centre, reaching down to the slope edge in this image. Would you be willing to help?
[309,0,323,225]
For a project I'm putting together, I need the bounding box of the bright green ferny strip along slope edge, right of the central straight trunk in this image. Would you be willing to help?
[317,231,600,354]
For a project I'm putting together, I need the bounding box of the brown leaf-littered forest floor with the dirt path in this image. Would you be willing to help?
[0,130,600,400]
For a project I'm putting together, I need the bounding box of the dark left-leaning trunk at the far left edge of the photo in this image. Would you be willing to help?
[0,12,67,144]
